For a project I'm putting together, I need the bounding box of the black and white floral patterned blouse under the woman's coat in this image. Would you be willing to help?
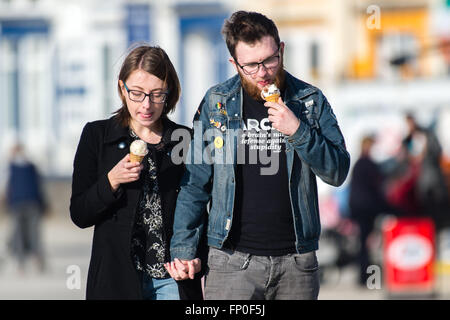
[130,131,169,279]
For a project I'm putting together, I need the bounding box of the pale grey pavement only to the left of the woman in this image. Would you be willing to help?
[0,218,93,300]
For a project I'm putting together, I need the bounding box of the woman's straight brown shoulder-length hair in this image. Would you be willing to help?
[114,45,181,126]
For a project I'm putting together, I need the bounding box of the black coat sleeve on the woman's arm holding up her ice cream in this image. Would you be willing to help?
[70,123,122,228]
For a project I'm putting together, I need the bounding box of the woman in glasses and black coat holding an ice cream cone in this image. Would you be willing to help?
[70,46,202,300]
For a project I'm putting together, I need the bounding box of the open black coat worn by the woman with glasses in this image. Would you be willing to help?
[70,117,201,299]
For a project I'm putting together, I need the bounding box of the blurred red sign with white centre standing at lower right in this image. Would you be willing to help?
[383,218,435,293]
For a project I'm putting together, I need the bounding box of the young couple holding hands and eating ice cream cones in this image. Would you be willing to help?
[70,11,350,300]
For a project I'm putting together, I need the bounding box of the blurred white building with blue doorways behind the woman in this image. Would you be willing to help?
[0,0,231,182]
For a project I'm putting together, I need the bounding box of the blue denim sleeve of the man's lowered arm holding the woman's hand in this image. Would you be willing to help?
[170,94,213,260]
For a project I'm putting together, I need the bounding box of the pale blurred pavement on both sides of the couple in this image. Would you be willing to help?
[0,216,450,300]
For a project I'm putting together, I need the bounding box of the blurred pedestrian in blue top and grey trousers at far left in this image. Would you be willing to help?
[6,143,46,272]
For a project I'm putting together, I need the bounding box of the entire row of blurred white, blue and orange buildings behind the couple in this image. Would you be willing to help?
[0,0,450,182]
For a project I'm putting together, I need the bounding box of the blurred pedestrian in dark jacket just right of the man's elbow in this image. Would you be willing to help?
[349,135,390,285]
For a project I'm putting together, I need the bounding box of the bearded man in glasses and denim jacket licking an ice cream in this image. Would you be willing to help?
[166,11,350,299]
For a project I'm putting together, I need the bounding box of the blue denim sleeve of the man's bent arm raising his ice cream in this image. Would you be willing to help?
[287,92,350,186]
